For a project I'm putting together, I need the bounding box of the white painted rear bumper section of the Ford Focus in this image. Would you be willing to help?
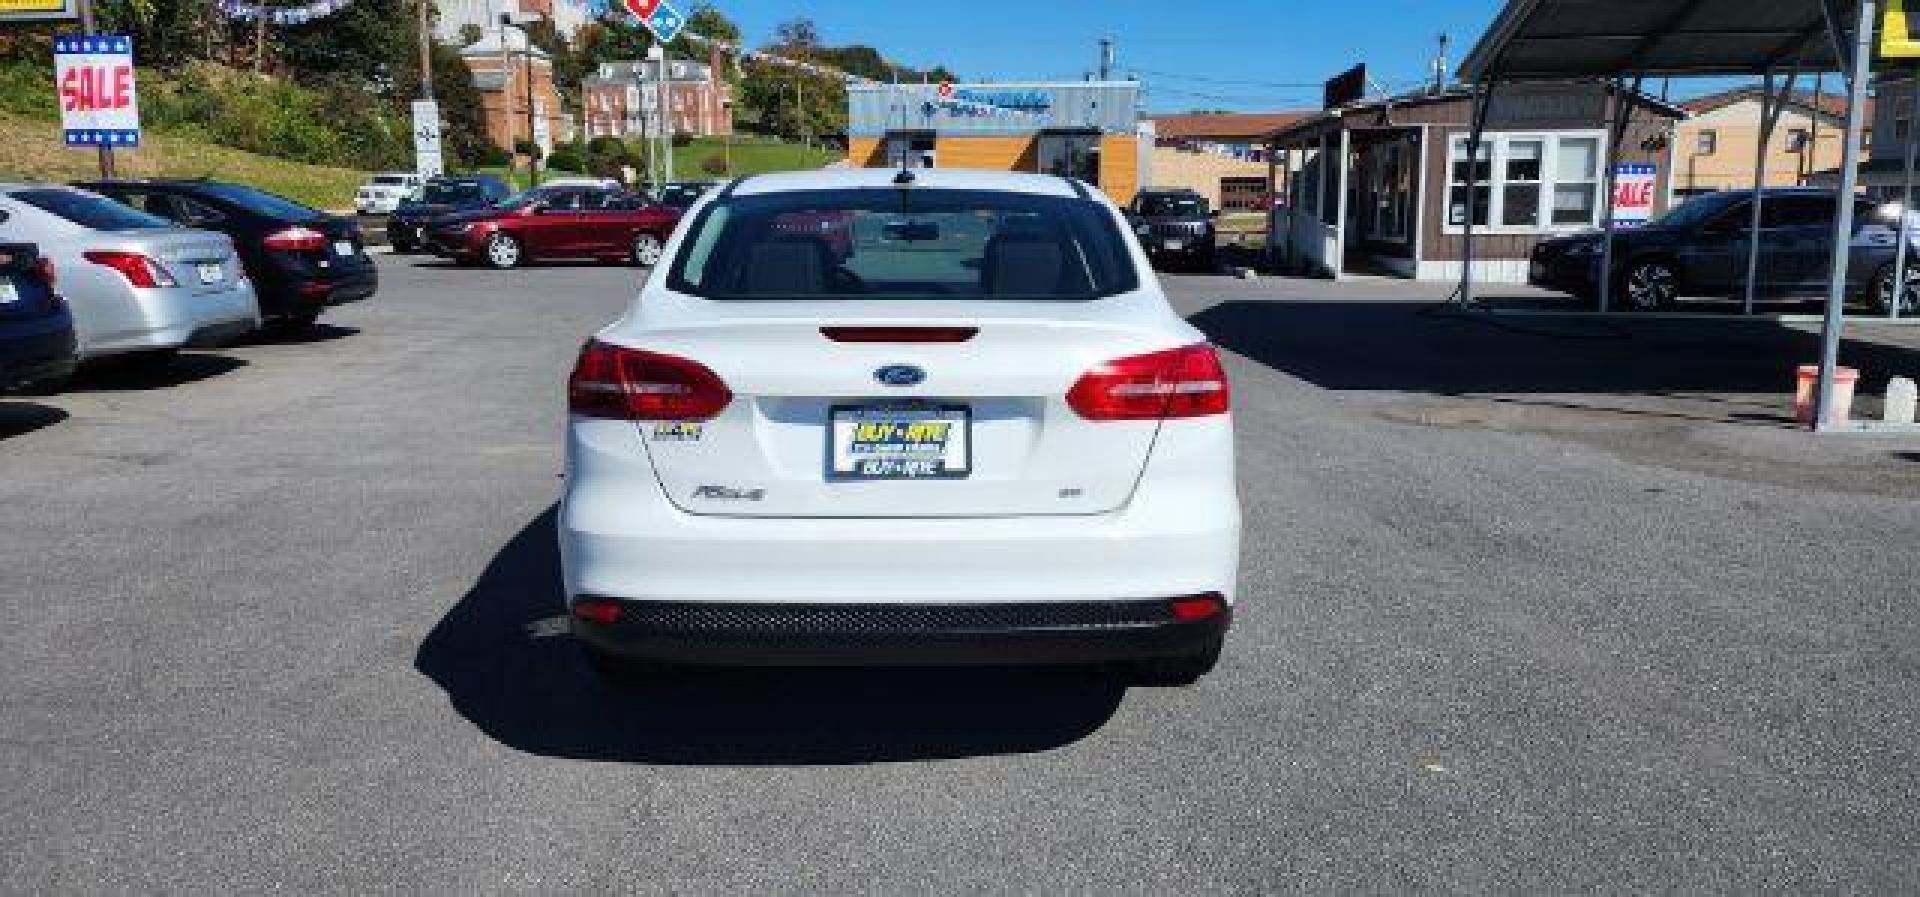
[559,419,1240,605]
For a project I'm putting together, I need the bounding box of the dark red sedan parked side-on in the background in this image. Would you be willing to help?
[422,186,680,267]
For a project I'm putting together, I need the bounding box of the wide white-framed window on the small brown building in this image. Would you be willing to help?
[1446,134,1599,232]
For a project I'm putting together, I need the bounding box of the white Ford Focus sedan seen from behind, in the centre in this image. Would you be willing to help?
[559,169,1240,684]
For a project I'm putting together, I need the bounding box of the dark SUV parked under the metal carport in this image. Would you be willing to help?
[1526,188,1920,313]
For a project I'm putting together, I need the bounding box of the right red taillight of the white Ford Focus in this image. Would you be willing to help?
[1068,342,1229,421]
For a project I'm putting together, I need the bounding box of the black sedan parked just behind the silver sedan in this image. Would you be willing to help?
[77,181,380,332]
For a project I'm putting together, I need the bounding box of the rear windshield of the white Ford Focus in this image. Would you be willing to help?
[668,188,1139,300]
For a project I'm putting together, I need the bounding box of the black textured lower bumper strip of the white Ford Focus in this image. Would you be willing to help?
[572,601,1231,667]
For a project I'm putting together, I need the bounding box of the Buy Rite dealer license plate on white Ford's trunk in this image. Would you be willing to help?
[828,403,973,480]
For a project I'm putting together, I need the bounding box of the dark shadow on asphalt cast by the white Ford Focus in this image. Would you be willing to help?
[415,509,1125,766]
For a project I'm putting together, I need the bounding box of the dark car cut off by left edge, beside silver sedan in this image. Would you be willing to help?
[0,242,77,392]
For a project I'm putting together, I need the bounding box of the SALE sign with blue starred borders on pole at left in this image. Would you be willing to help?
[54,35,140,146]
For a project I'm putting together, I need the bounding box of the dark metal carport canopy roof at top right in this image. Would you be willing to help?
[1459,0,1853,83]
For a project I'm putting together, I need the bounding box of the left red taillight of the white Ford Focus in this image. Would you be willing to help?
[566,340,733,421]
